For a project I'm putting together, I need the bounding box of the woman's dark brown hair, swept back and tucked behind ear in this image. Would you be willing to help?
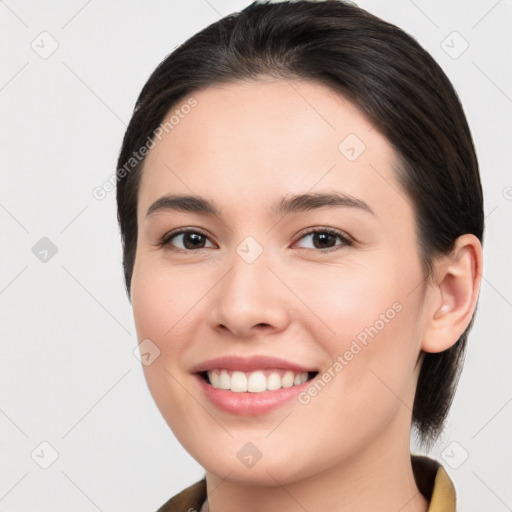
[117,0,484,445]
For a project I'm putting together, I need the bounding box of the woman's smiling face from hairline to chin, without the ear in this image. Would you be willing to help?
[131,79,428,485]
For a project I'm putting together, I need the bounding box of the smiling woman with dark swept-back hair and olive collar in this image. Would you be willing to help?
[117,0,483,512]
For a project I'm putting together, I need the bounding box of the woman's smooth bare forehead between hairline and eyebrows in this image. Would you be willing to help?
[139,79,404,222]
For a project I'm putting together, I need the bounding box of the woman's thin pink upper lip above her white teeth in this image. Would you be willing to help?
[192,355,316,373]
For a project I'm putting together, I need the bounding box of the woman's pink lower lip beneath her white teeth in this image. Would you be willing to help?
[196,374,311,416]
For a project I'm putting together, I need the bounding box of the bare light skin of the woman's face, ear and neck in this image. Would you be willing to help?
[131,78,482,512]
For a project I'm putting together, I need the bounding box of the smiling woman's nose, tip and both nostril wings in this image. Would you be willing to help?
[205,255,290,339]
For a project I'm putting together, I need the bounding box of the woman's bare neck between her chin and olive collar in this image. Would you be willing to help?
[206,414,428,512]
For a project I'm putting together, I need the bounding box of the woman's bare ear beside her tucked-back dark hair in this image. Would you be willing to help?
[421,234,483,352]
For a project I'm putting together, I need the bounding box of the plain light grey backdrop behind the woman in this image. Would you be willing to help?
[0,0,512,512]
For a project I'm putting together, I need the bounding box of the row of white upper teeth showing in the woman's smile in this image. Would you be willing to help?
[207,370,308,393]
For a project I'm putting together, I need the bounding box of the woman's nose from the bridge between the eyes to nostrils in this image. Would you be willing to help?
[210,242,289,337]
